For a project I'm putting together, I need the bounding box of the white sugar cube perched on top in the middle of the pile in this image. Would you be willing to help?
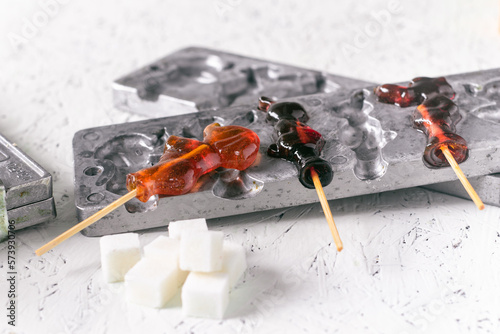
[179,231,224,272]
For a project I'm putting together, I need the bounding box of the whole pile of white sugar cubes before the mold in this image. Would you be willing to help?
[100,218,247,319]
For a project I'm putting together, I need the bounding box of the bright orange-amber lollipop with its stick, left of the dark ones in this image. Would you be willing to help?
[35,123,260,256]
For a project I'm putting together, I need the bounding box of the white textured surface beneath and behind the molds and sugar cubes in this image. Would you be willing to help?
[0,0,500,334]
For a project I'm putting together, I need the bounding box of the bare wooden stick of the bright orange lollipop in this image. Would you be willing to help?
[35,189,137,256]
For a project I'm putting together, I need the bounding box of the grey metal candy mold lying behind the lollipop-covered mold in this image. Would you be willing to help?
[113,47,368,117]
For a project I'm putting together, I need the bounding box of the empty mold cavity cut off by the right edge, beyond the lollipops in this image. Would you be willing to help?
[460,79,500,123]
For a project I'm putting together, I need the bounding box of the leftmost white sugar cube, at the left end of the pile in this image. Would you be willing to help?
[100,233,141,283]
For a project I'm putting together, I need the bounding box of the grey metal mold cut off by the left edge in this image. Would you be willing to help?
[0,135,56,229]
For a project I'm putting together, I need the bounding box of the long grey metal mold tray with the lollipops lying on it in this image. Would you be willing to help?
[73,70,500,236]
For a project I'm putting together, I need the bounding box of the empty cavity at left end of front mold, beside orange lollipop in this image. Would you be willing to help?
[91,129,167,212]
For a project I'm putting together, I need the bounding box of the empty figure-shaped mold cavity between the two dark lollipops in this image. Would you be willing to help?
[332,91,396,180]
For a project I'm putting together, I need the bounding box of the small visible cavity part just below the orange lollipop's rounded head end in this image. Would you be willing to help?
[212,169,264,200]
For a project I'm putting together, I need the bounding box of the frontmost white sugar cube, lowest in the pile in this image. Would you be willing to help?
[181,272,229,319]
